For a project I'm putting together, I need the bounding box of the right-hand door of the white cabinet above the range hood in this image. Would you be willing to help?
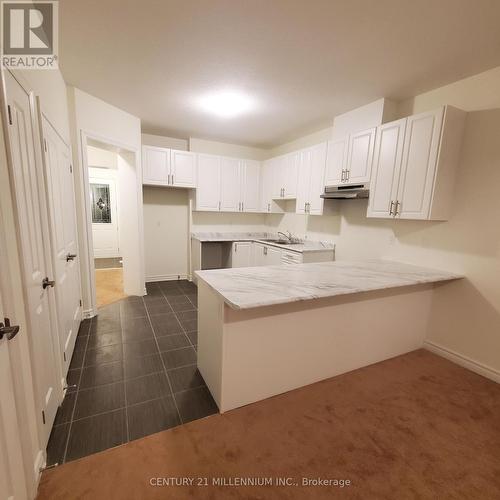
[346,128,376,184]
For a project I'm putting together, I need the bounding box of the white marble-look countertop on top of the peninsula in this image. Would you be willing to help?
[196,260,463,309]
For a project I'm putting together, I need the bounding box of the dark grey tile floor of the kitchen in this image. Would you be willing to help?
[47,281,217,465]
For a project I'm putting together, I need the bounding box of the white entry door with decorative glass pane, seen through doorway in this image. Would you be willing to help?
[89,176,120,259]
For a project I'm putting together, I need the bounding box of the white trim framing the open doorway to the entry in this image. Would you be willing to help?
[77,129,145,318]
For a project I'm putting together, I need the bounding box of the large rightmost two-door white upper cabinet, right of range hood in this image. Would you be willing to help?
[367,106,466,220]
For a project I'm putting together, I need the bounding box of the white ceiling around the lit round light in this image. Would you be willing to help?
[60,0,500,147]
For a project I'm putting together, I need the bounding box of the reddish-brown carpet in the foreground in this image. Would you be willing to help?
[39,350,500,500]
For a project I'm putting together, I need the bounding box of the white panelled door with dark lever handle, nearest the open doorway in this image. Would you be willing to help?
[42,117,82,377]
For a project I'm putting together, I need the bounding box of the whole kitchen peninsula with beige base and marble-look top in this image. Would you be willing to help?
[196,260,461,412]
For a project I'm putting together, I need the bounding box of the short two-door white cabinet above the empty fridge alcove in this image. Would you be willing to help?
[142,146,196,188]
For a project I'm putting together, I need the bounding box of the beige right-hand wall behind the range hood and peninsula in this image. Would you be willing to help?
[267,68,500,372]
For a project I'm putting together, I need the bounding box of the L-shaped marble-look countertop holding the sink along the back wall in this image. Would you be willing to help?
[191,232,335,253]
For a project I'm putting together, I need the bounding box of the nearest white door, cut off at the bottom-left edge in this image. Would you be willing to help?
[0,284,27,500]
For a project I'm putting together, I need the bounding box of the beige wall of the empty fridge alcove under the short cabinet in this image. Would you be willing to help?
[143,186,189,281]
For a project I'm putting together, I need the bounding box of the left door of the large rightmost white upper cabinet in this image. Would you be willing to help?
[367,118,407,218]
